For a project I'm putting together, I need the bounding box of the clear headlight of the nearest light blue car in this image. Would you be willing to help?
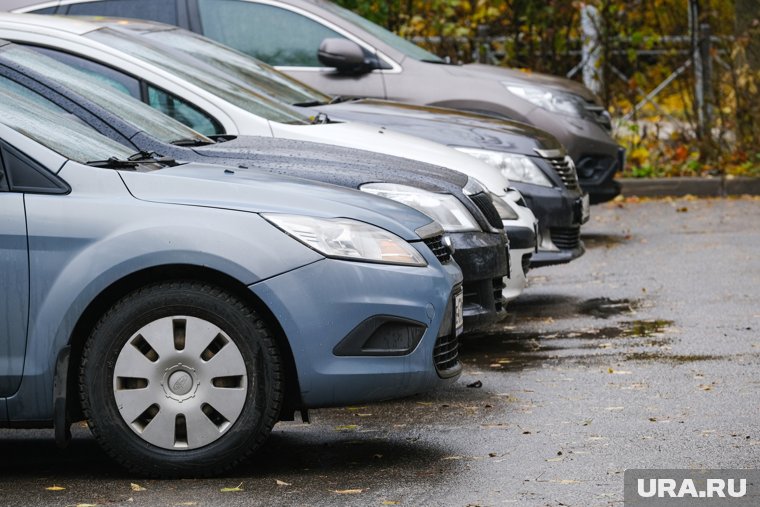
[262,213,427,266]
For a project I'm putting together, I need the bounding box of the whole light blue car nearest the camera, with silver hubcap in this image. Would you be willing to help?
[0,78,462,476]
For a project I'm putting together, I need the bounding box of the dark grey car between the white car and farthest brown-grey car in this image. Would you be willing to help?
[89,18,589,267]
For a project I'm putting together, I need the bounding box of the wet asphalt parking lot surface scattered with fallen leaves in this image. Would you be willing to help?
[0,198,760,507]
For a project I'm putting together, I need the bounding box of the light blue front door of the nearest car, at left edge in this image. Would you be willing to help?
[0,138,29,397]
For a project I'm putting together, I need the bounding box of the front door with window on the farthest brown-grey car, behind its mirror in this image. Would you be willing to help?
[189,0,385,97]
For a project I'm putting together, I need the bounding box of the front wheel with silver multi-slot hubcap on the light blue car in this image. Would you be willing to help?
[80,281,283,477]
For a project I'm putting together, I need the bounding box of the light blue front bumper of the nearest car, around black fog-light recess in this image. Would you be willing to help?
[250,251,462,408]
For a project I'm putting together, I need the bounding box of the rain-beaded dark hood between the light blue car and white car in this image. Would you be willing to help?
[187,136,467,193]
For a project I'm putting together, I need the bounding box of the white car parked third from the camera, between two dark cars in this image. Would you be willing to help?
[0,14,535,299]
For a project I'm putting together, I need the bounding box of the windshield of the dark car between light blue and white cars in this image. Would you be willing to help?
[1,46,214,144]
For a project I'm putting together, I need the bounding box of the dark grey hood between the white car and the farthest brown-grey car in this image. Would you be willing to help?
[311,99,562,156]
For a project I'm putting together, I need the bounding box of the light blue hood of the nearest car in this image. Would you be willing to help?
[120,164,432,241]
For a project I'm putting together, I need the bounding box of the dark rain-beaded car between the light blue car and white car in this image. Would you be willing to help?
[0,41,510,326]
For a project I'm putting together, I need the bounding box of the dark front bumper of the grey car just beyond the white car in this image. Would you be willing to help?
[511,182,585,268]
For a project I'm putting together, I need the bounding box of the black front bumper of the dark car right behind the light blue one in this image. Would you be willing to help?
[448,232,509,332]
